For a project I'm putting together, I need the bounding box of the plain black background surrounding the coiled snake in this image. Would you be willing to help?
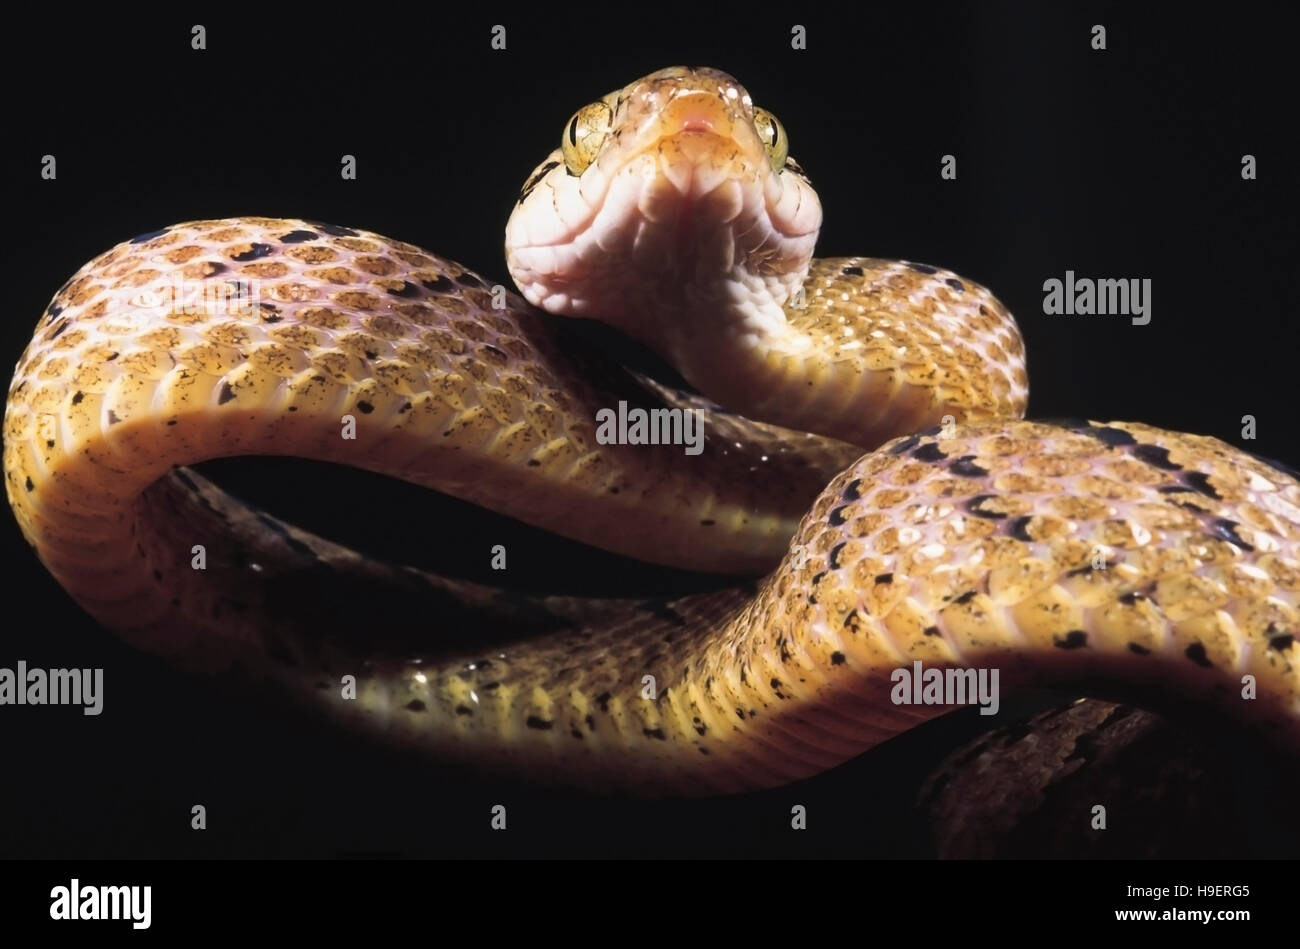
[0,4,1300,857]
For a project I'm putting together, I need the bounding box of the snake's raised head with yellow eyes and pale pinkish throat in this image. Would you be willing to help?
[506,66,822,351]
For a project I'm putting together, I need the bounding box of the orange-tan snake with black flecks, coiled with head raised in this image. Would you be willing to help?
[4,66,1300,796]
